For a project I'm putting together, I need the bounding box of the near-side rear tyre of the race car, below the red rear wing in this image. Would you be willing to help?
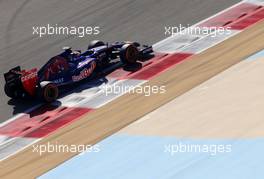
[38,82,59,103]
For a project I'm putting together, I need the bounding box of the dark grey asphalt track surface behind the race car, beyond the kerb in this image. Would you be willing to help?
[0,0,238,122]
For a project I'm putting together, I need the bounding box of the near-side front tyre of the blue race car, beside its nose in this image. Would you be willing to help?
[120,44,139,64]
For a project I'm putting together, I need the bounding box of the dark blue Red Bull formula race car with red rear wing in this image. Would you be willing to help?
[4,40,153,102]
